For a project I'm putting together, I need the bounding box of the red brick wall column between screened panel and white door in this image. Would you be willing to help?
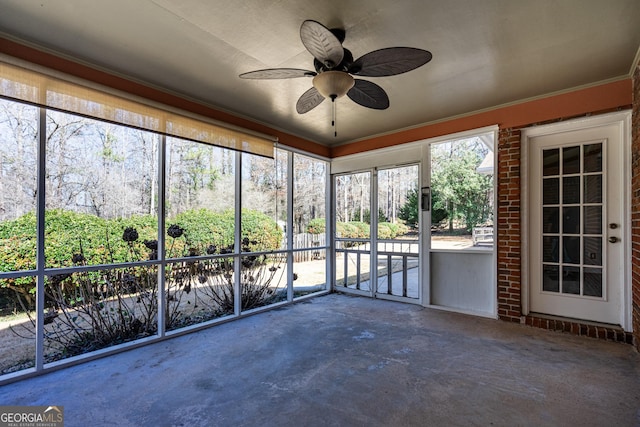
[497,129,522,322]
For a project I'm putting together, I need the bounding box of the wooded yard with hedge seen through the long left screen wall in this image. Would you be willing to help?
[0,96,328,373]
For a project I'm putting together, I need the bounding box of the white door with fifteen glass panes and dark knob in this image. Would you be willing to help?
[526,118,626,325]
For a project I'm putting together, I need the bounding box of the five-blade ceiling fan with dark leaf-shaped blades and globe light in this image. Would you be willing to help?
[240,20,432,135]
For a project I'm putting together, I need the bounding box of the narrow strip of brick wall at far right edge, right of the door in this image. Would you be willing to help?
[631,65,640,350]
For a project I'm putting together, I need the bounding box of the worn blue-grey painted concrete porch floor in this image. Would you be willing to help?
[0,294,640,427]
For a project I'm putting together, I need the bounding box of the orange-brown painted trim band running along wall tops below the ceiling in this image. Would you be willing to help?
[0,37,632,158]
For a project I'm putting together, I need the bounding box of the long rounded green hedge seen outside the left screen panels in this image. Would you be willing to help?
[0,209,283,305]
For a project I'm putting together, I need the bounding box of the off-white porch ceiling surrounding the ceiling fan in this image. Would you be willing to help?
[0,0,640,145]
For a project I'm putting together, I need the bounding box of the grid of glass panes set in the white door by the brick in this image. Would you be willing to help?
[542,143,605,298]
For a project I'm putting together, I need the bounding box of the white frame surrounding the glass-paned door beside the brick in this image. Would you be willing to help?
[520,110,632,332]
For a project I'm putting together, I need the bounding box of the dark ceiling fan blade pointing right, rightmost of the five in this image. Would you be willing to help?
[349,47,433,77]
